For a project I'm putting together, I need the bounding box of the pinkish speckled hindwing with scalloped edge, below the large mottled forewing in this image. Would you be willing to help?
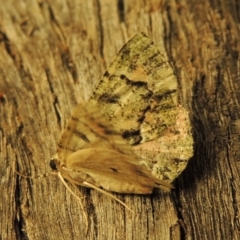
[132,106,193,182]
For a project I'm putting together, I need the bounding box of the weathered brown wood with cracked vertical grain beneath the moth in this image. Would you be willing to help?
[0,0,240,240]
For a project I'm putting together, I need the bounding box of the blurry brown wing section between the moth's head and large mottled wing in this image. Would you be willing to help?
[57,102,134,164]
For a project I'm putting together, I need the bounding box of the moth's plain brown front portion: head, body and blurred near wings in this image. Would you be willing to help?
[53,102,172,194]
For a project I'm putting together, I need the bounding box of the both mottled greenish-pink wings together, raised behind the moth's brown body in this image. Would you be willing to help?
[90,33,193,182]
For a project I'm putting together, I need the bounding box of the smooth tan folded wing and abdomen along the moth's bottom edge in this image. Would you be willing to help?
[64,148,171,194]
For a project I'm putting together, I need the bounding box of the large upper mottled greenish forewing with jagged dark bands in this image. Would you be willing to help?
[92,33,178,144]
